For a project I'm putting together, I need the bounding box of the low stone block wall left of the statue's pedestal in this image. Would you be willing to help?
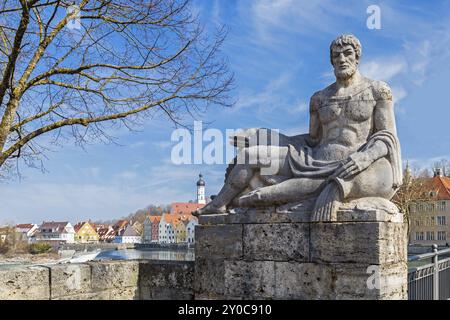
[0,260,194,300]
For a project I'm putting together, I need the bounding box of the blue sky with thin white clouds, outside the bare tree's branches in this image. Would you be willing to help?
[0,0,450,223]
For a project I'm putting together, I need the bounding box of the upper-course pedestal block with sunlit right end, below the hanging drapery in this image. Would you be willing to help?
[310,222,407,265]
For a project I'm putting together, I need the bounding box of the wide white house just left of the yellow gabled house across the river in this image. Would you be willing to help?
[35,221,75,243]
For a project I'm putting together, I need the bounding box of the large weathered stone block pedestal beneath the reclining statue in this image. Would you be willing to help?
[194,202,407,299]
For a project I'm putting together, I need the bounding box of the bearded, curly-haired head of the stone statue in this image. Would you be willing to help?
[330,34,361,80]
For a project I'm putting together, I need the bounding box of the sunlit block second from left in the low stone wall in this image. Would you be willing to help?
[50,264,92,299]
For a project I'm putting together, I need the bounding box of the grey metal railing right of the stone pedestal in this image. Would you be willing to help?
[408,244,450,300]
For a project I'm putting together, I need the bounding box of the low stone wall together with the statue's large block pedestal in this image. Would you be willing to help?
[0,208,407,300]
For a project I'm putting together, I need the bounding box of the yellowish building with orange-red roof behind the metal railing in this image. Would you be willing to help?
[409,169,450,246]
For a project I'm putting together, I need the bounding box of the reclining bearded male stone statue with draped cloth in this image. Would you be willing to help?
[194,35,402,221]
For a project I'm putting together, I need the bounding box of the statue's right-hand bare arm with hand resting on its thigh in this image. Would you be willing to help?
[334,82,397,179]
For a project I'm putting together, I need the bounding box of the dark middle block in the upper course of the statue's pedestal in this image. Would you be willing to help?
[244,223,309,261]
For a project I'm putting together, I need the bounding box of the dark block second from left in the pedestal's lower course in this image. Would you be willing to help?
[225,261,275,299]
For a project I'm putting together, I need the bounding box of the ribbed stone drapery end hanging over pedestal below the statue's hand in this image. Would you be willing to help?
[311,183,341,222]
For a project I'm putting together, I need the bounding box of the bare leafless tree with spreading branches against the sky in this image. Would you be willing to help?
[0,0,232,175]
